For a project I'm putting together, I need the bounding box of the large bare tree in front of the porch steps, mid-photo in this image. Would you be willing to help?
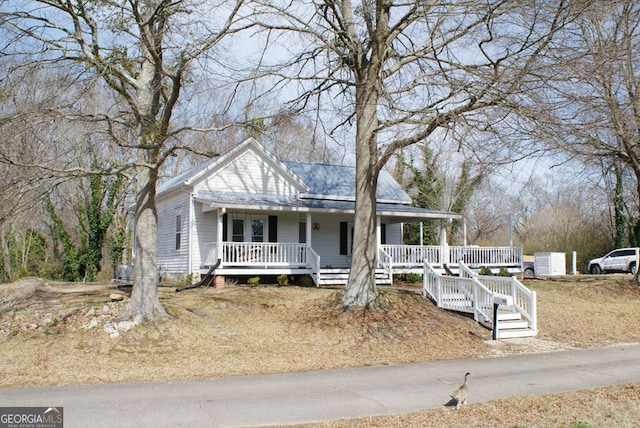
[255,0,574,307]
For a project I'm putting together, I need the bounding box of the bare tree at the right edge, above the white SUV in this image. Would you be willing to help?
[539,0,640,245]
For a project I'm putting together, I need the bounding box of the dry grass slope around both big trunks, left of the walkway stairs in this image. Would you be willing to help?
[0,281,490,387]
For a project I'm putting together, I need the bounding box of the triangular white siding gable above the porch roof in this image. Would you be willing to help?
[195,151,295,196]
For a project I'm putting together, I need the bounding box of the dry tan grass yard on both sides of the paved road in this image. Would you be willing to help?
[0,275,640,427]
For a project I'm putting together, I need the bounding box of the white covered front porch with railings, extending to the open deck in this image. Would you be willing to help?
[194,197,523,285]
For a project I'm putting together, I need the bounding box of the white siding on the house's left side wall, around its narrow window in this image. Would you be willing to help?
[158,192,189,273]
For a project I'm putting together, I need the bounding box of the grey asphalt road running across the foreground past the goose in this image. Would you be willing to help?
[0,344,640,428]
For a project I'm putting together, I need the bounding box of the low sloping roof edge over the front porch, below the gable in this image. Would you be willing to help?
[194,193,462,222]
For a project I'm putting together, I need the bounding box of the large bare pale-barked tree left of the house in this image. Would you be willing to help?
[0,0,244,321]
